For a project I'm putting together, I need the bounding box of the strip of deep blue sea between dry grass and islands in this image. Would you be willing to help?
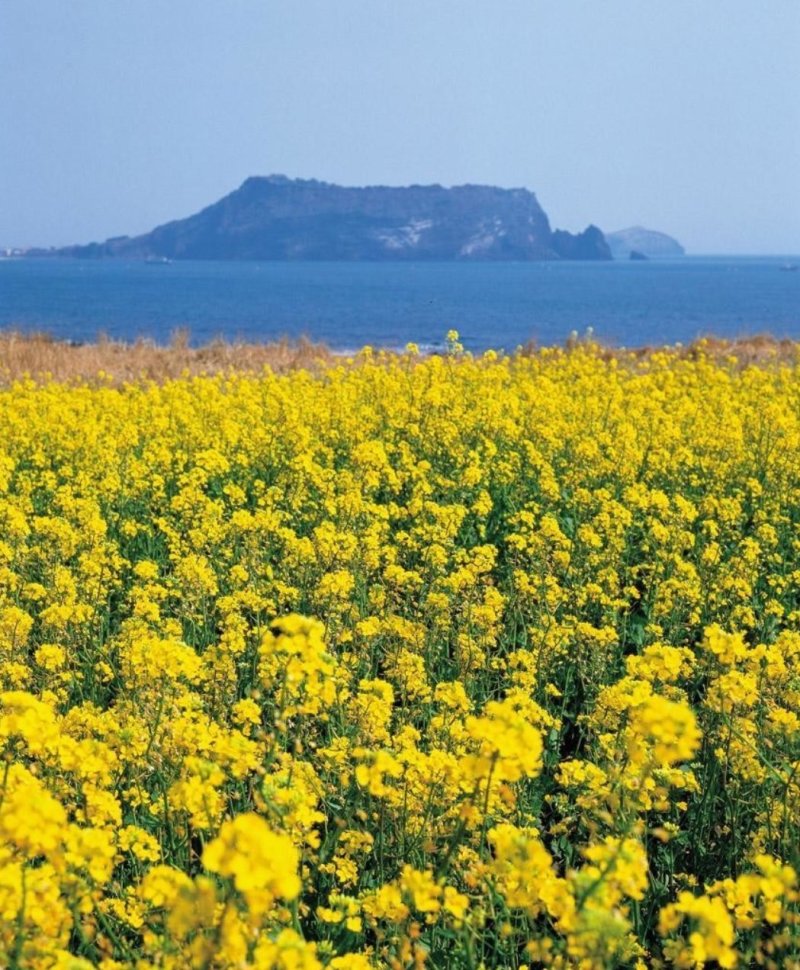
[0,257,800,350]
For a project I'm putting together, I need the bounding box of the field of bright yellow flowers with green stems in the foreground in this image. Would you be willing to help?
[0,336,800,970]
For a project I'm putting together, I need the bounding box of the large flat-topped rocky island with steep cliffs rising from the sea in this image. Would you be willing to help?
[57,175,612,261]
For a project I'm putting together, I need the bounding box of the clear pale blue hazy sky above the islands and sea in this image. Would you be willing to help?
[0,0,800,253]
